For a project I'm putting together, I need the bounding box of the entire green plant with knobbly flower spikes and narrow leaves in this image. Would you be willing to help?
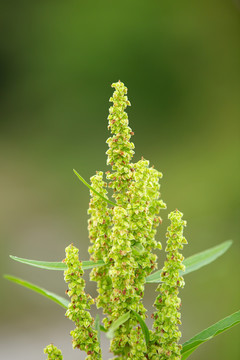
[5,81,240,360]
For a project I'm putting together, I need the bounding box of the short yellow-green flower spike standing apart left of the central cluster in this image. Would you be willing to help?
[64,245,102,360]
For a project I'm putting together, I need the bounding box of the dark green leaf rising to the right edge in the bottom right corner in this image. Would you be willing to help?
[182,310,240,360]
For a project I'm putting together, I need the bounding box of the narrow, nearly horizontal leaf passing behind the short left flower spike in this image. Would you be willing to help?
[10,255,105,270]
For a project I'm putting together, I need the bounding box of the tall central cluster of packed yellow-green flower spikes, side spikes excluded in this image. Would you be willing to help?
[89,82,165,359]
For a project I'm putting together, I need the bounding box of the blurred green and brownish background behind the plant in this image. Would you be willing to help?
[0,0,240,360]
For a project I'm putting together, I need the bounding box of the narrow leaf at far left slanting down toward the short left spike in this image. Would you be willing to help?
[4,275,69,309]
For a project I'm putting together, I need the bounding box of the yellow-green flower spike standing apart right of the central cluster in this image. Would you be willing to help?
[149,210,187,360]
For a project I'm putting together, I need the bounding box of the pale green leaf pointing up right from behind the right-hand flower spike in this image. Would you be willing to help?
[146,240,232,283]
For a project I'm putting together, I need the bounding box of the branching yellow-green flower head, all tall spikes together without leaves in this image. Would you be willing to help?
[44,81,186,360]
